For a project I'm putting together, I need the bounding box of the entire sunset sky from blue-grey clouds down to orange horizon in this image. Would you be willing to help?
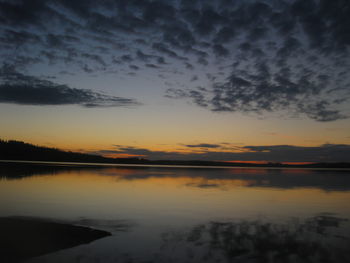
[0,0,350,162]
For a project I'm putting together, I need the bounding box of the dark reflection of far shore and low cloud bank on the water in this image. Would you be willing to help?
[0,164,350,191]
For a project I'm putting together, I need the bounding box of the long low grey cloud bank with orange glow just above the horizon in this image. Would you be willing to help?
[96,143,350,162]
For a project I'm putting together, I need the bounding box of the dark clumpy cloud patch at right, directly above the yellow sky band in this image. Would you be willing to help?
[172,58,349,121]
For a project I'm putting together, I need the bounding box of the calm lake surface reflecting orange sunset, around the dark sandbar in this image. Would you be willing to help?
[0,165,350,263]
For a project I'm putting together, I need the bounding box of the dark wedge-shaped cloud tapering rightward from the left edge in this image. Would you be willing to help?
[0,65,139,107]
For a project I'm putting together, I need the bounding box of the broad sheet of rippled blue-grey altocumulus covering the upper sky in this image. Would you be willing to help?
[0,0,350,122]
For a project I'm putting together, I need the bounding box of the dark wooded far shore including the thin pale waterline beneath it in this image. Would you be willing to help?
[0,139,350,169]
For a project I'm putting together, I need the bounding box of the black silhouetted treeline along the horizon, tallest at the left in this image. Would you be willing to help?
[0,139,350,168]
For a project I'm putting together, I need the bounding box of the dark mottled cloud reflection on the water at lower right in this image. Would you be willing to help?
[159,215,350,263]
